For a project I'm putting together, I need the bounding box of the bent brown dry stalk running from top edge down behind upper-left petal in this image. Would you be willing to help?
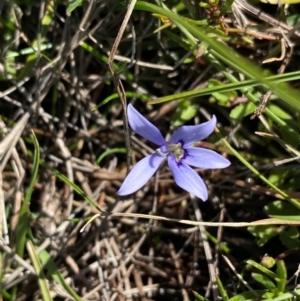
[108,0,137,171]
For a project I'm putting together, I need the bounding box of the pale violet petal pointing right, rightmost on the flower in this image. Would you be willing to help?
[182,147,231,169]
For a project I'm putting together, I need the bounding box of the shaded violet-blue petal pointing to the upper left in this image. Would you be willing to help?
[128,104,166,146]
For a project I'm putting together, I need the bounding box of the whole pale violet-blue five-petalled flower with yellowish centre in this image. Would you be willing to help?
[117,104,230,201]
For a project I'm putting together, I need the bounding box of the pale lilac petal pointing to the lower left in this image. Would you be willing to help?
[117,154,165,195]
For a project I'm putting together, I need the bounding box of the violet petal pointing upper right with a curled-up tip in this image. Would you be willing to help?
[170,115,217,146]
